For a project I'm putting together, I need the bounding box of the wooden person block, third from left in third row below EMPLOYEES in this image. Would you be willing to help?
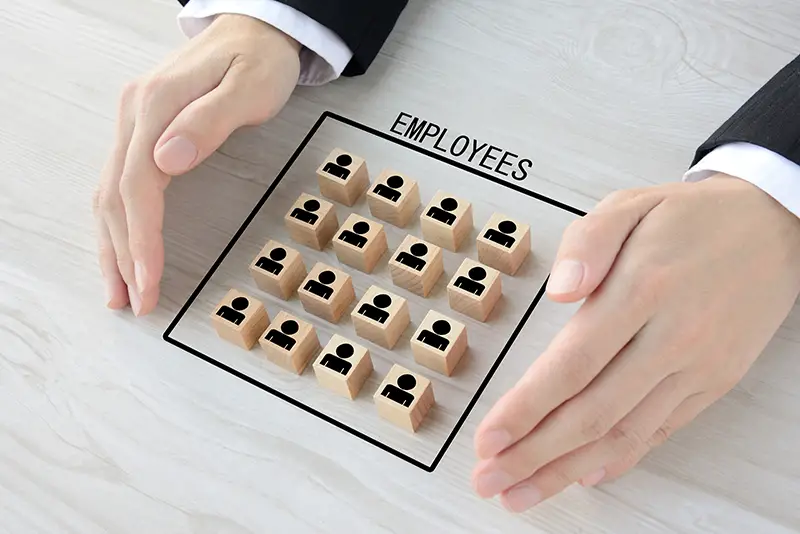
[350,286,411,349]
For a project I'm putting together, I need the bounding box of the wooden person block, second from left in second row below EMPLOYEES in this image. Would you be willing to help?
[333,213,387,273]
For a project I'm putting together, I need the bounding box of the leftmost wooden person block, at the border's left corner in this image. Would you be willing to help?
[211,289,269,350]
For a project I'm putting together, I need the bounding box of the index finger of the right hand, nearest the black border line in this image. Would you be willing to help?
[475,254,658,459]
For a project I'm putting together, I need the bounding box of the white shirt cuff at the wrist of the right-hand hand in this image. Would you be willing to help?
[683,143,800,217]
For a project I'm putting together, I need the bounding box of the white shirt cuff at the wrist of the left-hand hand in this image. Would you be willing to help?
[178,0,353,85]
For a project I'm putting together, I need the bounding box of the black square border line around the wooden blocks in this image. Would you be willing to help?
[162,111,586,473]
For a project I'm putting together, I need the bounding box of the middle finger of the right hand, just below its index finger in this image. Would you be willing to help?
[475,318,685,497]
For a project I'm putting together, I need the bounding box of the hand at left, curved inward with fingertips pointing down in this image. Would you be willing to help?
[94,15,300,315]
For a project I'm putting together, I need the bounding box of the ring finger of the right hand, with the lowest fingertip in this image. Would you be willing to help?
[494,374,688,513]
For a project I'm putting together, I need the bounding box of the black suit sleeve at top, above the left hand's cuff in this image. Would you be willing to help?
[179,0,408,76]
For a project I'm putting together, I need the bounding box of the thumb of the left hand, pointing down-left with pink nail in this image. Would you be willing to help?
[153,77,274,176]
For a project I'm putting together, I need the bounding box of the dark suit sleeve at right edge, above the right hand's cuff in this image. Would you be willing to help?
[692,56,800,165]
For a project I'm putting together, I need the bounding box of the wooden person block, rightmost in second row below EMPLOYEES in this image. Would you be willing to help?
[447,258,503,321]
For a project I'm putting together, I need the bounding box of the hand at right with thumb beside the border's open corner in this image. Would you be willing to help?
[473,175,800,512]
